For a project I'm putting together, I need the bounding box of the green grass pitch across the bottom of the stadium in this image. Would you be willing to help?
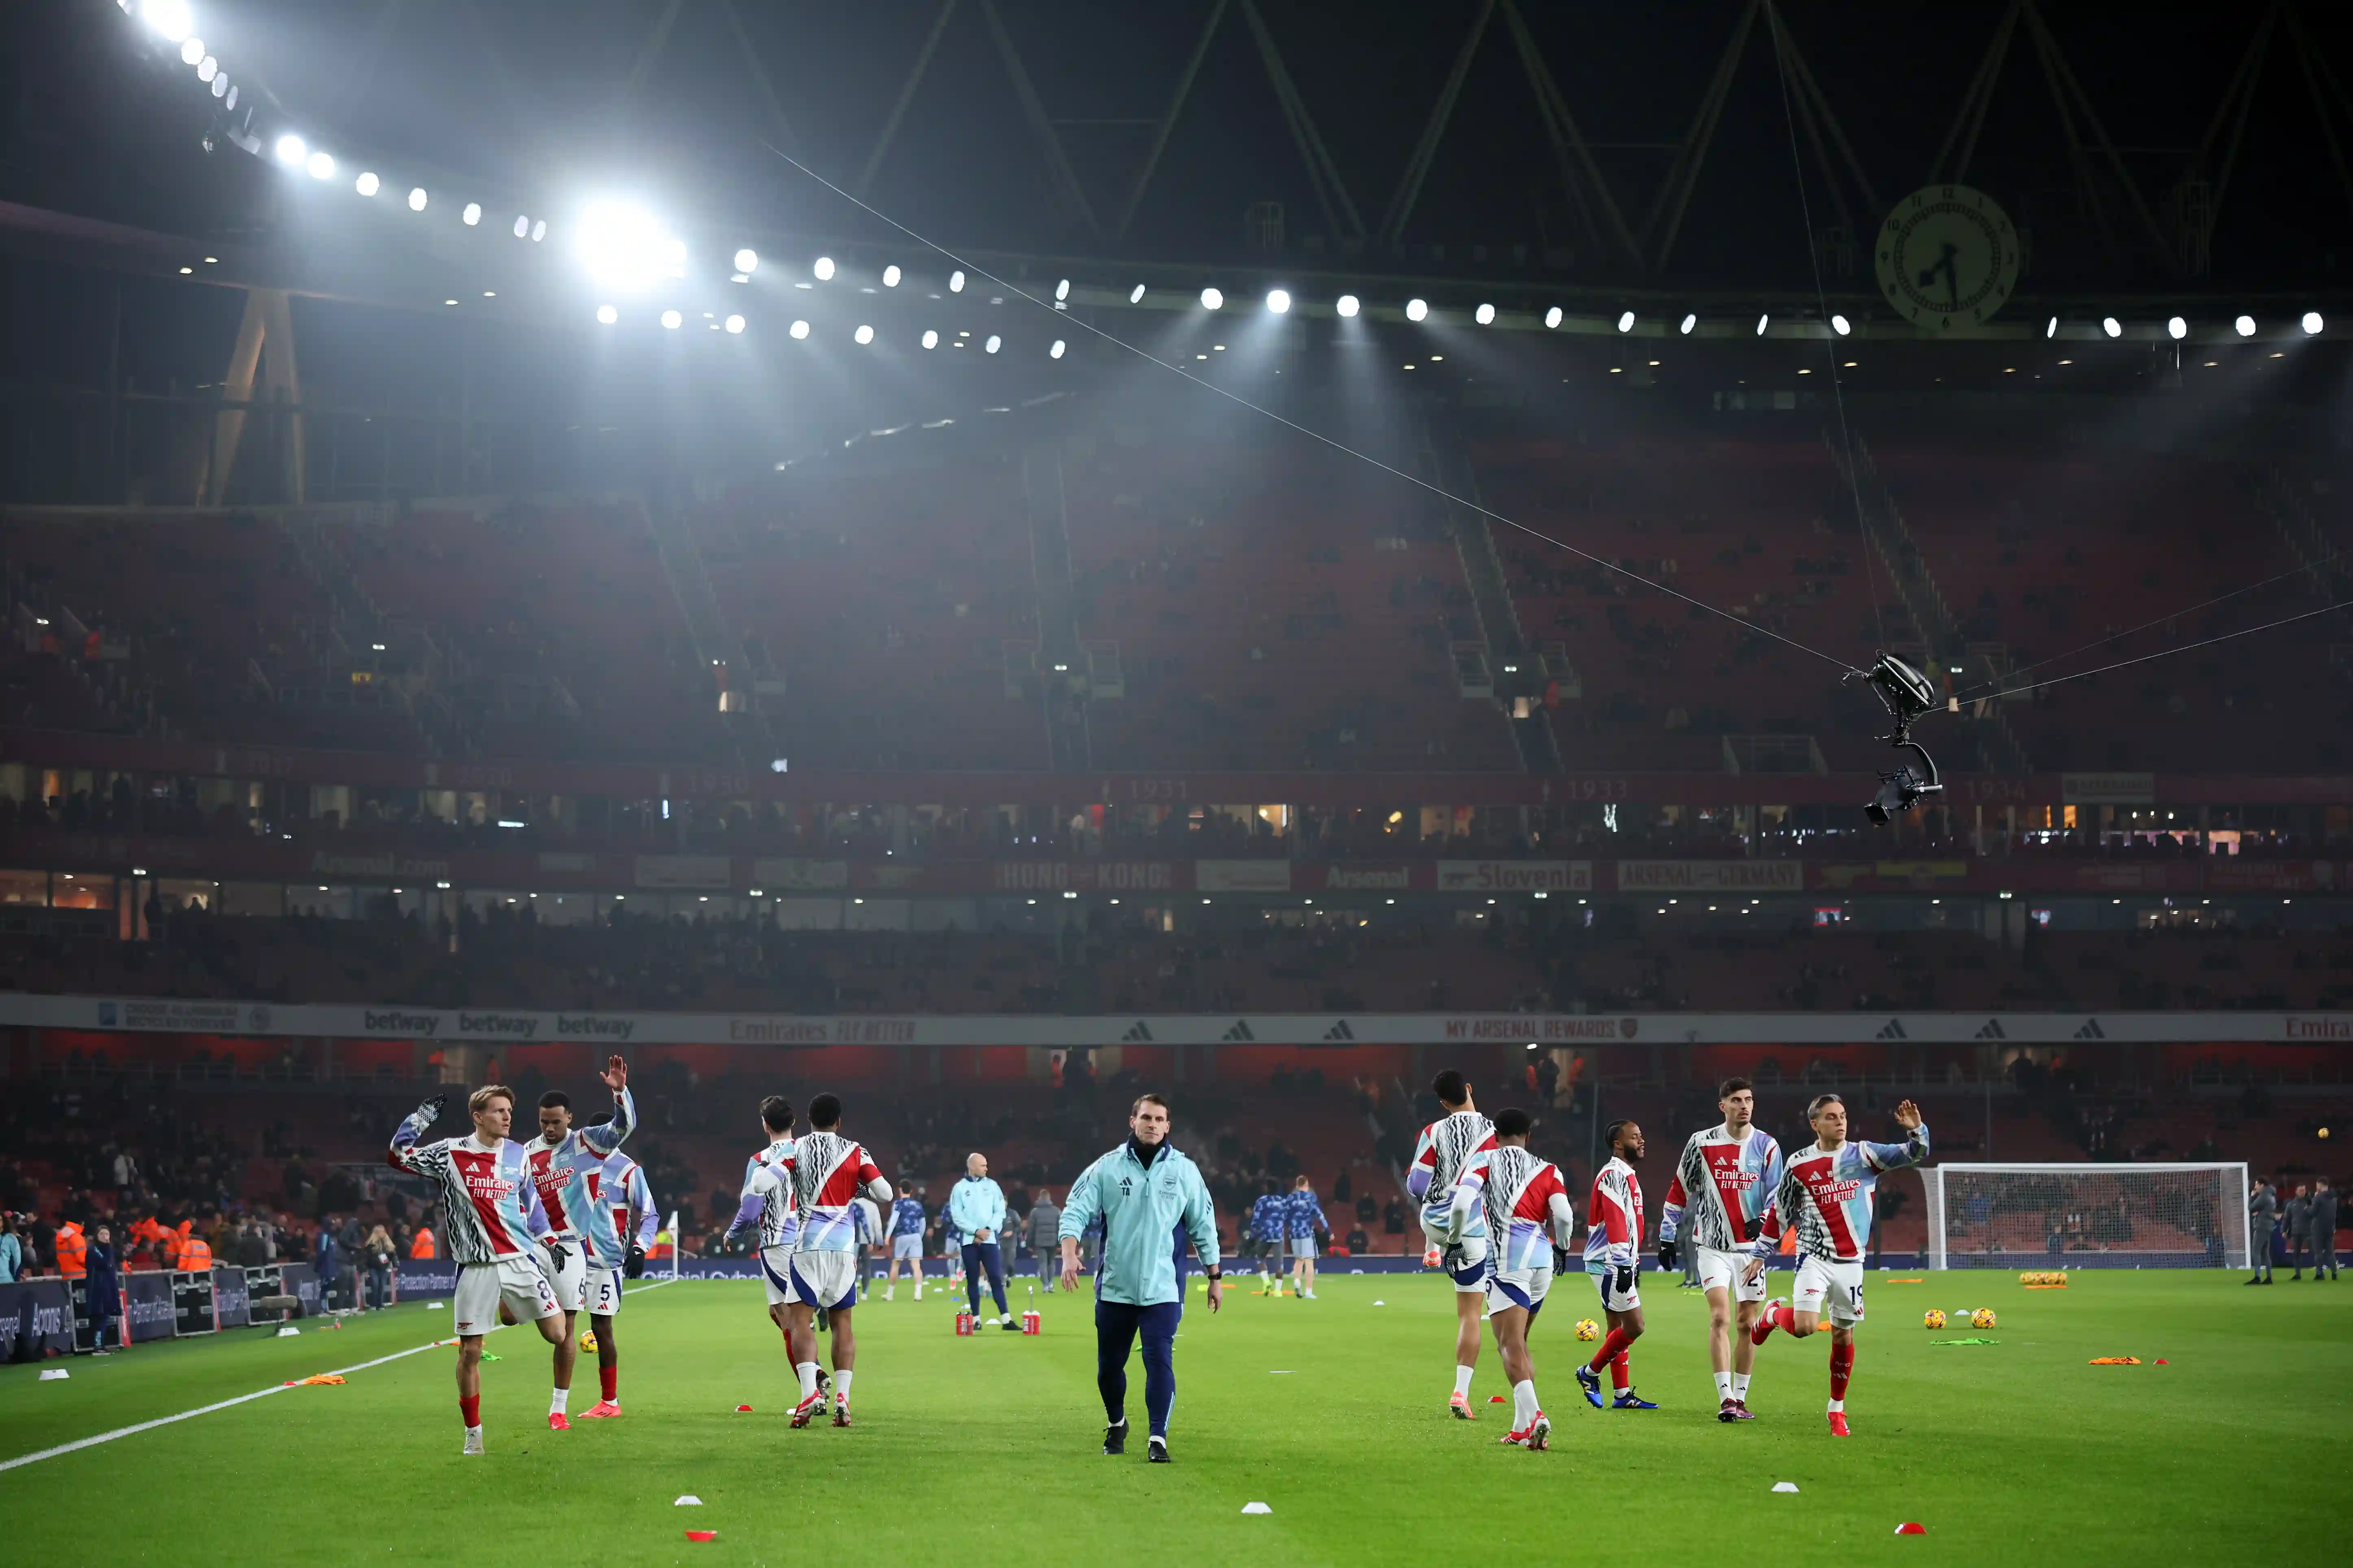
[0,1272,2353,1568]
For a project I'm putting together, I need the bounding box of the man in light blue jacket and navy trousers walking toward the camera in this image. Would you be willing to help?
[1059,1093,1224,1464]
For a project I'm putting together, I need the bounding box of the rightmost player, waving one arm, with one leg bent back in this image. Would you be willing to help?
[1746,1095,1927,1436]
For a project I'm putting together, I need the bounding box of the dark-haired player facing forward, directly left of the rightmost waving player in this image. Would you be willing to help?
[1659,1079,1781,1422]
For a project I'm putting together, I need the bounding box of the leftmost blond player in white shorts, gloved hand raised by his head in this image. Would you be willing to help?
[383,1086,574,1453]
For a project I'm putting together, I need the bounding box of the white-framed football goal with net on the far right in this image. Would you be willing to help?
[1920,1164,2247,1269]
